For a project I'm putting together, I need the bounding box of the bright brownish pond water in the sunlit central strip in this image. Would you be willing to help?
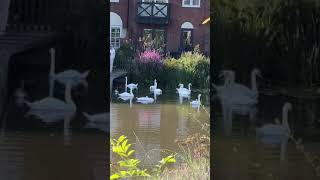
[110,82,210,166]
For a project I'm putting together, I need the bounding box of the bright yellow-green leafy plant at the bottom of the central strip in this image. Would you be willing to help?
[110,135,176,179]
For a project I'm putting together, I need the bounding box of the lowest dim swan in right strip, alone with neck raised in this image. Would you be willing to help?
[256,102,292,140]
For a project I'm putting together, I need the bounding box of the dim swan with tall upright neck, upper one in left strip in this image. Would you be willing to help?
[49,48,90,95]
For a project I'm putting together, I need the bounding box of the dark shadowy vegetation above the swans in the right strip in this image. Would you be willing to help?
[211,0,320,88]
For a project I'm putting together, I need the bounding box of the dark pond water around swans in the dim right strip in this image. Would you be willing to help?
[211,95,320,180]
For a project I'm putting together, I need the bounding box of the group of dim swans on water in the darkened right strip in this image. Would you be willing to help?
[214,69,292,160]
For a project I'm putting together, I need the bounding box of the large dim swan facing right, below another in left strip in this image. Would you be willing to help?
[25,81,77,123]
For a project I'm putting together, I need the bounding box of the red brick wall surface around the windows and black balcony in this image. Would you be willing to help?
[110,0,210,53]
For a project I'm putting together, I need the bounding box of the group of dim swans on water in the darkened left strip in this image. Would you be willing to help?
[18,48,107,132]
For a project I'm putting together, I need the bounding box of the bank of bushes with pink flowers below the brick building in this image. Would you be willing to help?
[114,42,210,89]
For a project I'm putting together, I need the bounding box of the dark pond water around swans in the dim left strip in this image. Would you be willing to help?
[0,67,109,180]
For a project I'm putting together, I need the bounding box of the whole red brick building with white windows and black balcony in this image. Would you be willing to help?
[110,0,210,55]
